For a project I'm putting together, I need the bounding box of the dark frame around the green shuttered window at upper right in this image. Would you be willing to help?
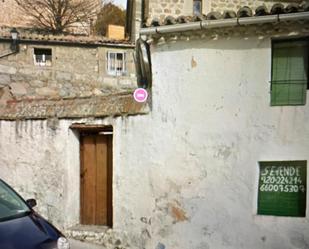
[270,36,309,106]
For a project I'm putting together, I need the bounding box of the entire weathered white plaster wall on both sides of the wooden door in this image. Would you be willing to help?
[0,33,309,249]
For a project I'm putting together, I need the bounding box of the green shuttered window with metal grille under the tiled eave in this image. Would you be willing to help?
[271,38,309,106]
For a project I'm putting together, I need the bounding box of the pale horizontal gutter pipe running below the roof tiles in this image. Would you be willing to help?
[140,12,309,35]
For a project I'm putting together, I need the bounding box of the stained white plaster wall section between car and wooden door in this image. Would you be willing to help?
[0,118,121,229]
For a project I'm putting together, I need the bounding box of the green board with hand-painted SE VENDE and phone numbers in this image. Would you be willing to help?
[258,161,307,217]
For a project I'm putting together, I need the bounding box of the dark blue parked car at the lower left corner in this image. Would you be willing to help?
[0,179,70,249]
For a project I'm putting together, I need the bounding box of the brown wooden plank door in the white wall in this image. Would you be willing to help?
[80,133,112,226]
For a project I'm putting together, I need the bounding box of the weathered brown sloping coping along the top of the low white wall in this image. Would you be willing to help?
[0,93,149,120]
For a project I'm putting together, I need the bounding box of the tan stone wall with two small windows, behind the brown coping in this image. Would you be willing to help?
[0,39,136,117]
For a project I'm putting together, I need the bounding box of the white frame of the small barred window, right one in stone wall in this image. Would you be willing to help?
[106,51,127,76]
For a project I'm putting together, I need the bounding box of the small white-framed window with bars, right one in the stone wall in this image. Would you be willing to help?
[107,52,126,76]
